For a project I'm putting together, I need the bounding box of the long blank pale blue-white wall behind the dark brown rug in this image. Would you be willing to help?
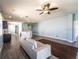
[33,14,78,42]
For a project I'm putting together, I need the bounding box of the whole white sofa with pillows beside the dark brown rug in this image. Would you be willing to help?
[20,39,51,59]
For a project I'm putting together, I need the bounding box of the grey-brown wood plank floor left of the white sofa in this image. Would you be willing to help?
[0,35,30,59]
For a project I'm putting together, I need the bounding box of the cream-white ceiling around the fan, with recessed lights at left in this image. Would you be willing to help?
[0,0,78,22]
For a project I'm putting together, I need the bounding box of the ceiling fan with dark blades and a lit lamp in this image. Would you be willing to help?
[36,3,58,15]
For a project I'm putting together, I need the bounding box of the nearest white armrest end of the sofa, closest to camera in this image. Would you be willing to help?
[34,44,51,59]
